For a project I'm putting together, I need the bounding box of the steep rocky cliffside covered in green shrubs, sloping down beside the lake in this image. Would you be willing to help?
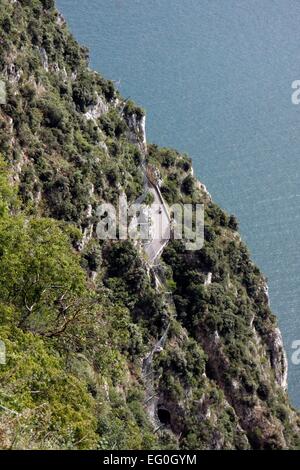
[0,0,299,449]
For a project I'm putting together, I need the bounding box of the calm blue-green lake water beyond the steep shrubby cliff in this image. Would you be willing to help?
[57,0,300,407]
